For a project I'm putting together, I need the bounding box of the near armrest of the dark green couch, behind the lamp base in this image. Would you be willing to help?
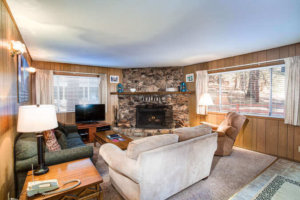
[16,146,93,172]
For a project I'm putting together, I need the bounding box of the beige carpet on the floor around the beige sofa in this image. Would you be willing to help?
[93,147,276,200]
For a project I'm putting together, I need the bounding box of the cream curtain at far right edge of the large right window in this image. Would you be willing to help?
[284,56,300,126]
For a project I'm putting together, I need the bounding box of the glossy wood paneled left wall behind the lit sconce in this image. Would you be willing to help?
[0,0,31,199]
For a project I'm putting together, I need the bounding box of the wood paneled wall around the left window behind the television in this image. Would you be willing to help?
[32,61,123,124]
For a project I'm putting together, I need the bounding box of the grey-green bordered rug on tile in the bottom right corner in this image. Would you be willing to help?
[253,175,300,200]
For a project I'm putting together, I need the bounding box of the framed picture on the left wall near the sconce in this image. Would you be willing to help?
[18,55,30,103]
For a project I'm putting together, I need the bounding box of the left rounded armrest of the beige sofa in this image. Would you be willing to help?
[99,143,140,183]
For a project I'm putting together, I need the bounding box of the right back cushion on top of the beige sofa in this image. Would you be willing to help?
[173,124,212,142]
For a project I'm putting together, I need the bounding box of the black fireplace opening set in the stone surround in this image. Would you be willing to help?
[136,105,173,129]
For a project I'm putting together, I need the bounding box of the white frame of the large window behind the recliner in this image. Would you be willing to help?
[207,64,285,119]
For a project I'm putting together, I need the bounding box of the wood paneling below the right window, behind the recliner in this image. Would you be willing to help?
[200,113,300,161]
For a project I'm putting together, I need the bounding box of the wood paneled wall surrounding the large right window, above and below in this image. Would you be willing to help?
[184,43,300,161]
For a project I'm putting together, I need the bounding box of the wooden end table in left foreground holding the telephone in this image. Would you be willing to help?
[20,158,103,200]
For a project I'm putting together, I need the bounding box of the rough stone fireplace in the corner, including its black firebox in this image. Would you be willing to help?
[115,67,189,136]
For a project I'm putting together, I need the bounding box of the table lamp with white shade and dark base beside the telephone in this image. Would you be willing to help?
[17,105,58,175]
